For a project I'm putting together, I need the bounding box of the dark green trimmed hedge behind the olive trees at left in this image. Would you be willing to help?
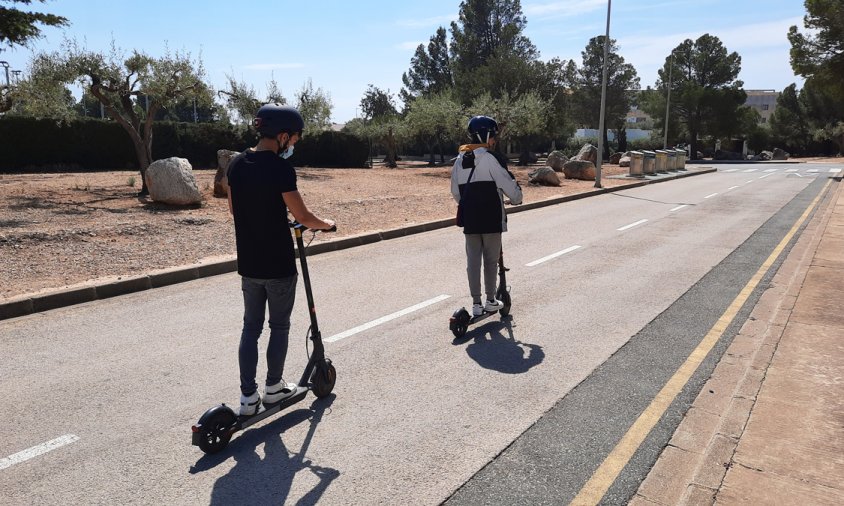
[0,116,369,172]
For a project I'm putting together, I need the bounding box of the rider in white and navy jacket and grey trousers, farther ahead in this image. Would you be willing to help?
[451,116,522,316]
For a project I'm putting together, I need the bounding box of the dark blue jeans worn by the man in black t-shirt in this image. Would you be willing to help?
[238,274,298,395]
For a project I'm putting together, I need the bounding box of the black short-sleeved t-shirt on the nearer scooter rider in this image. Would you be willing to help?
[228,151,296,279]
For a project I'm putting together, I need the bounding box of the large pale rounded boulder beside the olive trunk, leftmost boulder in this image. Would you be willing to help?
[146,156,202,206]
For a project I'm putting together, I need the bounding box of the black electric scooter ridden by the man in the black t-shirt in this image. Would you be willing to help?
[191,222,337,453]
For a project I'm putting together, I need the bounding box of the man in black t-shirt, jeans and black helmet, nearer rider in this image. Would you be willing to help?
[228,104,334,416]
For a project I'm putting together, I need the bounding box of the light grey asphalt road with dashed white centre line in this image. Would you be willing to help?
[0,165,834,504]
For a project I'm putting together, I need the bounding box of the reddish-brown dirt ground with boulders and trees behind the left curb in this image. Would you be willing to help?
[0,159,840,302]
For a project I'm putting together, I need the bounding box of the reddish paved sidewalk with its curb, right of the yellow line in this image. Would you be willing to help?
[630,178,844,506]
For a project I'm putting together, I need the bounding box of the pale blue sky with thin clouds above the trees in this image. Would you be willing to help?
[0,0,806,123]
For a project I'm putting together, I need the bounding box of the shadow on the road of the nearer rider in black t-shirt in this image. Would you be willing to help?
[192,394,340,505]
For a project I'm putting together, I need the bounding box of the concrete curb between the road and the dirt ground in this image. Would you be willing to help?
[0,168,717,320]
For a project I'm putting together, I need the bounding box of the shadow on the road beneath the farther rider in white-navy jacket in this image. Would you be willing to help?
[458,316,545,374]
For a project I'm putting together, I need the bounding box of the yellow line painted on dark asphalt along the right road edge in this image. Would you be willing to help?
[571,180,832,506]
